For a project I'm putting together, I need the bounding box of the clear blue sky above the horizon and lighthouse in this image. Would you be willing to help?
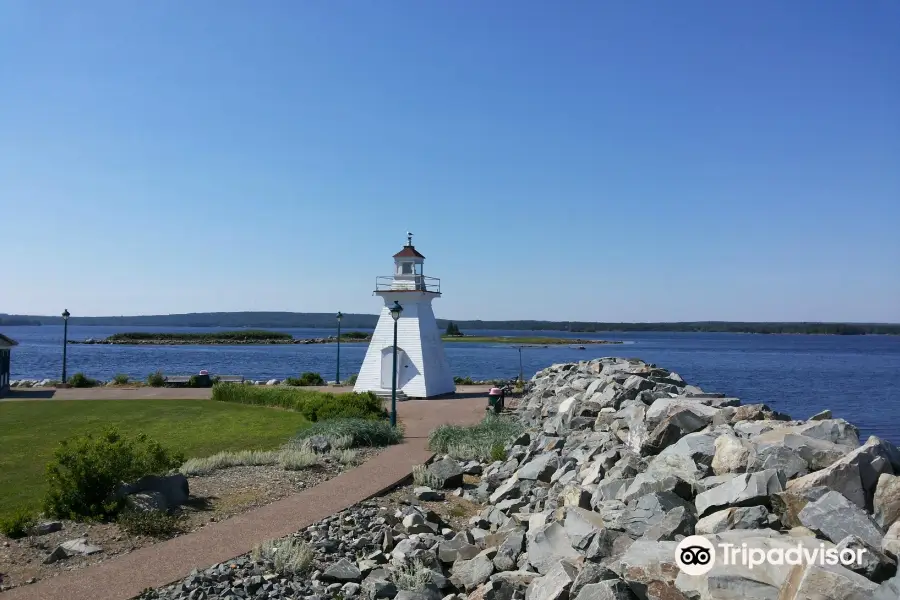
[0,0,900,322]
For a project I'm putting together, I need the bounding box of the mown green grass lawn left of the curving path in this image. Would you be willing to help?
[0,400,309,515]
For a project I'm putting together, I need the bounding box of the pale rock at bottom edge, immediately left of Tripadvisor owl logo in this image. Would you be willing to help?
[618,540,686,600]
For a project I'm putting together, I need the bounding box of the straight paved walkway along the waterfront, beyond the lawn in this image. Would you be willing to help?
[0,385,490,403]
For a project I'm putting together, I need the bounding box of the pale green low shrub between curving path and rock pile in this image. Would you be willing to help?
[428,415,523,461]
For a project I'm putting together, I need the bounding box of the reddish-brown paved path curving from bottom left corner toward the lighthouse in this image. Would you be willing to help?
[0,390,485,600]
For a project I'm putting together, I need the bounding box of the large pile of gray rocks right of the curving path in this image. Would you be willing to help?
[137,358,900,600]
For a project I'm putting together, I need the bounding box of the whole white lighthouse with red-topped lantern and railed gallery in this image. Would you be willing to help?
[353,233,456,398]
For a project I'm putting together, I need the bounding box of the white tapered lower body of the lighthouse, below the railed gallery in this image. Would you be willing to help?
[353,293,456,398]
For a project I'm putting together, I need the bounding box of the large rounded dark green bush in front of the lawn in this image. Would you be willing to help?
[44,428,184,520]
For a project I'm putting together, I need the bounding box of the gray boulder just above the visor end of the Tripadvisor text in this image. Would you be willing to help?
[798,492,884,548]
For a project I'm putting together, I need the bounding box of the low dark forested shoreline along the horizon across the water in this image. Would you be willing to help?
[0,312,900,335]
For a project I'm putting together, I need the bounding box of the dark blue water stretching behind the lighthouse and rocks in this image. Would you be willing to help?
[3,326,900,443]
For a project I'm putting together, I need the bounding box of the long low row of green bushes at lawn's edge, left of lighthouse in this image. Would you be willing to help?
[212,383,387,422]
